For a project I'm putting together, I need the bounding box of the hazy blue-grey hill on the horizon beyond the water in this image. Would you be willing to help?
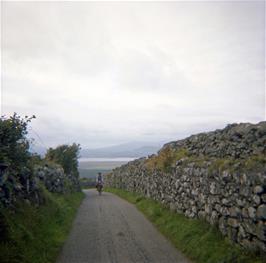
[81,142,162,158]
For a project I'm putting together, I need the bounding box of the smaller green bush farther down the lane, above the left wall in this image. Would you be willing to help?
[45,143,81,175]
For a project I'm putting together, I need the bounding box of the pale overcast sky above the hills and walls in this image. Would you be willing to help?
[1,1,265,151]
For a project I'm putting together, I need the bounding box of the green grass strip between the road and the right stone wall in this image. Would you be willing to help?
[105,188,265,263]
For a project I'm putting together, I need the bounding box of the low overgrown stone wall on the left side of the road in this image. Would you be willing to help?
[0,164,81,206]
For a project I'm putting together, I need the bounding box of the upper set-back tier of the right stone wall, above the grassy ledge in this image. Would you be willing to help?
[162,121,266,158]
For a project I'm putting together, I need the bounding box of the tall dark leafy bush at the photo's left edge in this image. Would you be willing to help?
[0,113,38,205]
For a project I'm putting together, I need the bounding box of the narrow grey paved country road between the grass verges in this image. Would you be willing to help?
[57,189,190,263]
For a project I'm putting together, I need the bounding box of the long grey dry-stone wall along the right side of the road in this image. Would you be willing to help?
[105,122,266,255]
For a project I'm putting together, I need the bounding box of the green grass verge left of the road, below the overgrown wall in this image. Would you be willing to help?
[0,191,84,263]
